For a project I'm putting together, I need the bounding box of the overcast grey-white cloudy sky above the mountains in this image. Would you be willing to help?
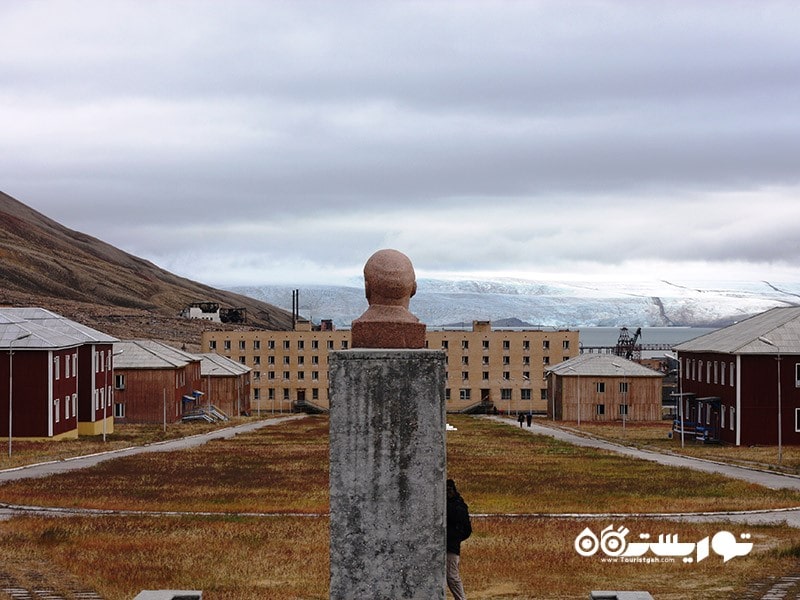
[0,0,800,285]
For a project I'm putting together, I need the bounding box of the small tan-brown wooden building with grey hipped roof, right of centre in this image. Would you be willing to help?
[547,354,664,422]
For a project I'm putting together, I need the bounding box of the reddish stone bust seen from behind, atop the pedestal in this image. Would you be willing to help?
[352,249,425,348]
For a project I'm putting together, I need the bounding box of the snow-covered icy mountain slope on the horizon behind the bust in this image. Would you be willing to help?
[232,279,800,328]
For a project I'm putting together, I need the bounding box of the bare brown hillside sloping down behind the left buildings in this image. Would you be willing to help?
[0,192,292,350]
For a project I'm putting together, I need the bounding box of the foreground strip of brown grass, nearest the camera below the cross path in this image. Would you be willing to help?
[0,517,798,600]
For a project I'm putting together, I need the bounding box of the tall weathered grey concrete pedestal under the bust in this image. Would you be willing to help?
[328,349,446,600]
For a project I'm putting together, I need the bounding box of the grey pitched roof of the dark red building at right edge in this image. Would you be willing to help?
[674,306,800,354]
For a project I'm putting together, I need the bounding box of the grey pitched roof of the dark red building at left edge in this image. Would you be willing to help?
[0,307,117,350]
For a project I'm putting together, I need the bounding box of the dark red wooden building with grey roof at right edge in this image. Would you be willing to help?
[675,307,800,446]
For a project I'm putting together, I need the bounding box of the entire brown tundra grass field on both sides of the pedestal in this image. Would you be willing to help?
[0,417,800,600]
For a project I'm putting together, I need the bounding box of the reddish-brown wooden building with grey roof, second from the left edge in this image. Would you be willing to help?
[114,340,205,423]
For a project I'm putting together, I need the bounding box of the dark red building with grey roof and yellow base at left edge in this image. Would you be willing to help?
[0,308,116,439]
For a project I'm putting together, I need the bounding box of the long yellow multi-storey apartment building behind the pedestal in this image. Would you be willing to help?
[202,321,580,413]
